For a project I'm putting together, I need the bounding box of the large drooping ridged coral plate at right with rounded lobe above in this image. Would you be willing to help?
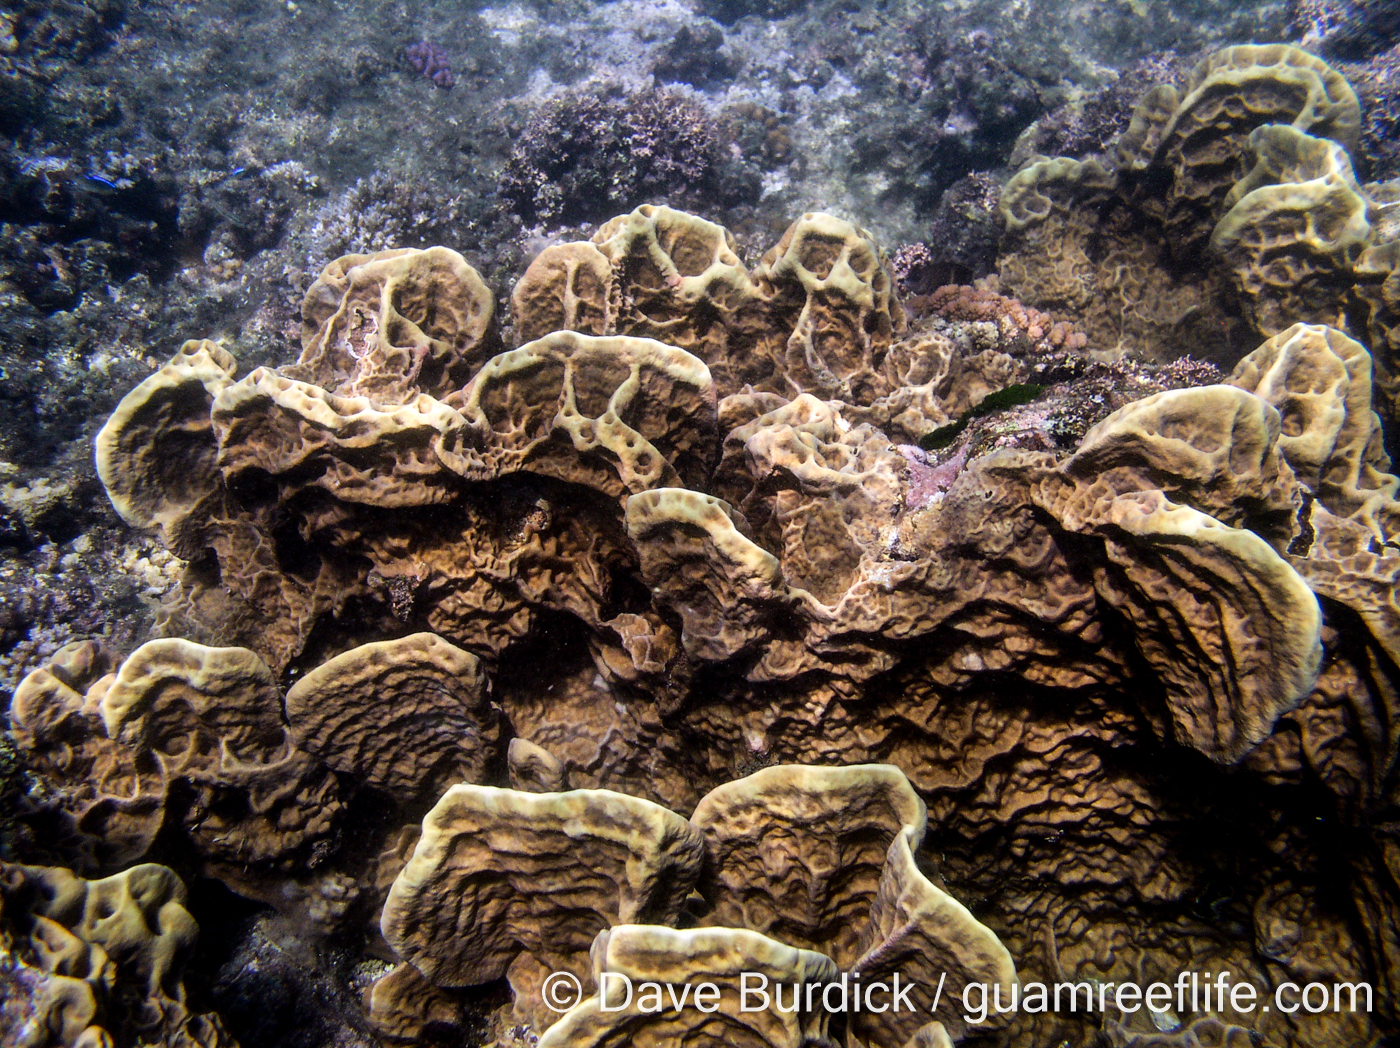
[1037,386,1322,761]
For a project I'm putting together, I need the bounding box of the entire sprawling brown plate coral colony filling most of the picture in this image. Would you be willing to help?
[11,48,1400,1048]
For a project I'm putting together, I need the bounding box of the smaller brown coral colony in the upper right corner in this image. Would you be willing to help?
[998,45,1396,436]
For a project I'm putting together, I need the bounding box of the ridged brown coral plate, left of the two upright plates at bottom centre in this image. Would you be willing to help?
[382,786,704,1031]
